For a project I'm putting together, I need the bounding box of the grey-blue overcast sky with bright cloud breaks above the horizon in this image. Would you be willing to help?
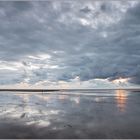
[0,0,140,88]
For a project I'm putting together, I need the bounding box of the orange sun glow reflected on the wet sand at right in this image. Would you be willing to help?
[115,89,127,112]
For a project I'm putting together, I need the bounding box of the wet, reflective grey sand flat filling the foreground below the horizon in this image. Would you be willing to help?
[0,90,140,139]
